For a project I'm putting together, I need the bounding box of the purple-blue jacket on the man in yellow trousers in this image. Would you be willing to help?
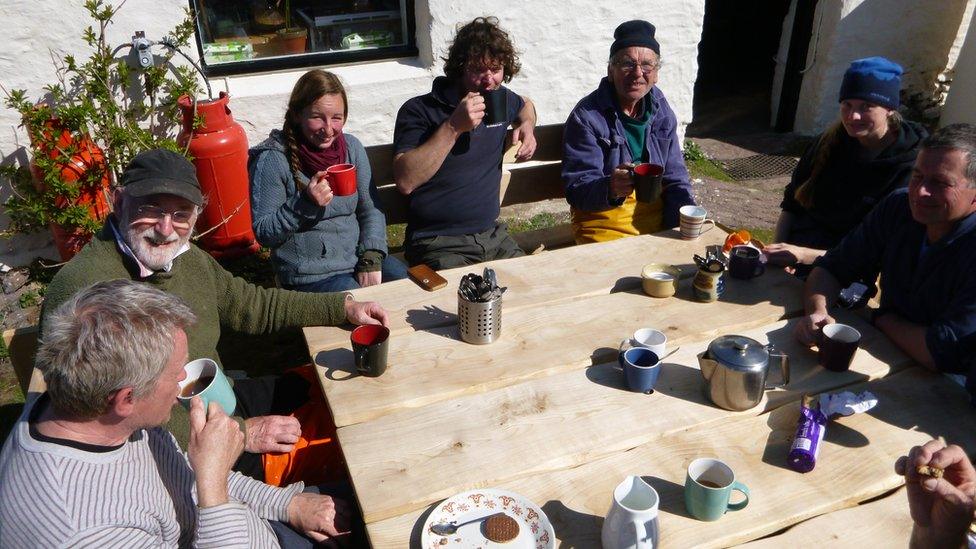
[563,78,695,228]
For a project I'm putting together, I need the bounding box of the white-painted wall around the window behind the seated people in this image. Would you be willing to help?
[0,0,705,265]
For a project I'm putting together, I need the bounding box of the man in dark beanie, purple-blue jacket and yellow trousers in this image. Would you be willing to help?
[562,20,695,244]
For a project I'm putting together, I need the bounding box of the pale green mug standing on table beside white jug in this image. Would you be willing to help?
[685,458,749,521]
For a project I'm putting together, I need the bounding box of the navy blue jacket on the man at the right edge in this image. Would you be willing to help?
[814,189,976,384]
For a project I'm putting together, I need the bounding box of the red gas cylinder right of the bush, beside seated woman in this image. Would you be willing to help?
[177,92,260,258]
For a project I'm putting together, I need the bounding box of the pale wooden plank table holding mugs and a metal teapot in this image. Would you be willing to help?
[305,230,976,547]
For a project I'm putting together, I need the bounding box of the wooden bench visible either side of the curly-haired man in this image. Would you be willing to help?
[366,124,574,252]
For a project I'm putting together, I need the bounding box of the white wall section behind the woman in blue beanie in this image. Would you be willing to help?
[780,0,972,134]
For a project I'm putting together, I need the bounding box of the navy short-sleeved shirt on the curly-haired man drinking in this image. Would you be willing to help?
[393,76,525,239]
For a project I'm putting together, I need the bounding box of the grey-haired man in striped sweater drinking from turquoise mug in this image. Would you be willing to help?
[0,280,349,548]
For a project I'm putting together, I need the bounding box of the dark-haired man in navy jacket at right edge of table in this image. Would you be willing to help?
[796,124,976,395]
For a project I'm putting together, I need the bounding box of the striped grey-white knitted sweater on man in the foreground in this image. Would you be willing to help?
[0,396,303,549]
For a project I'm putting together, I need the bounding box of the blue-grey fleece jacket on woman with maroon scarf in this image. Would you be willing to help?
[248,130,387,286]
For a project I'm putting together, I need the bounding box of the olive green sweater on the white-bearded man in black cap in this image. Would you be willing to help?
[40,219,346,448]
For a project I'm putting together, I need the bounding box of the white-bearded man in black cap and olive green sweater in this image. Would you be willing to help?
[41,149,386,479]
